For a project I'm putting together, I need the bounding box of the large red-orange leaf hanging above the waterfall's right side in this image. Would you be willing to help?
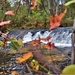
[50,9,67,30]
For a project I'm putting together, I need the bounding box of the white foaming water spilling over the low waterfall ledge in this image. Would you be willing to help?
[23,28,72,47]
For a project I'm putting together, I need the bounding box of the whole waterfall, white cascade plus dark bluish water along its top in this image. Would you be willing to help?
[0,27,72,48]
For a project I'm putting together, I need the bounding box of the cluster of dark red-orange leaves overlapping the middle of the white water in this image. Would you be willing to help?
[29,36,54,50]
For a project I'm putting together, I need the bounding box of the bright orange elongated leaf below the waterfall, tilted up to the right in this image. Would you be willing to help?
[16,52,33,63]
